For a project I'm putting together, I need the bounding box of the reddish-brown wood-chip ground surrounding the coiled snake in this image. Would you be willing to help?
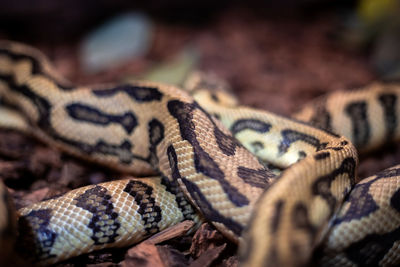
[0,7,400,267]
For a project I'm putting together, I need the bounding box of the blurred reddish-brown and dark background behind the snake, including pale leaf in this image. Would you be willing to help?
[0,0,400,114]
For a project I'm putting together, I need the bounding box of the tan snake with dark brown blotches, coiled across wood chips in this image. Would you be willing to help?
[0,41,400,266]
